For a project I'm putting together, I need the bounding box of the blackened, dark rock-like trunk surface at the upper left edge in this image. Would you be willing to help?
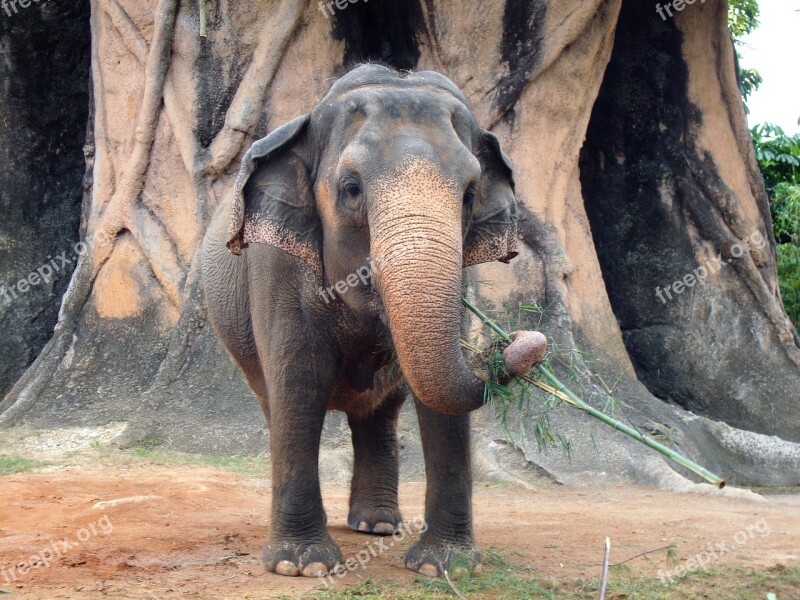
[0,0,91,398]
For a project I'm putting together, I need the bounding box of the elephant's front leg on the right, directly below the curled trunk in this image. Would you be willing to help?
[405,400,482,577]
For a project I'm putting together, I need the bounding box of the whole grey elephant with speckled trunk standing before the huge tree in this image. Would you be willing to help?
[201,64,546,577]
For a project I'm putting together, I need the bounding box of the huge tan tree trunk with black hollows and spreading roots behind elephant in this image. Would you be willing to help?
[0,0,800,487]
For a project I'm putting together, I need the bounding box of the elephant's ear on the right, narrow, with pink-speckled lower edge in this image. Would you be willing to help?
[464,130,518,267]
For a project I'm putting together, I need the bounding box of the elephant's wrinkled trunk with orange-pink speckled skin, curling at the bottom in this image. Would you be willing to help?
[369,157,484,415]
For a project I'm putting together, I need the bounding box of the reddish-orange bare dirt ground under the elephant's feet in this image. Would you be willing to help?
[0,461,800,599]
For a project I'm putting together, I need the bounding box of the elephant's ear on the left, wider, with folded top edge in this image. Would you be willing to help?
[228,115,322,278]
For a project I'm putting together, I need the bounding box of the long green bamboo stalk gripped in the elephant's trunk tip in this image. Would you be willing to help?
[462,297,725,488]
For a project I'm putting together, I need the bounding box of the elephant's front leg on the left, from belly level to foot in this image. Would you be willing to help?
[263,376,342,577]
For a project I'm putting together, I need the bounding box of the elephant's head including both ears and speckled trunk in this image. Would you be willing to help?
[228,65,517,414]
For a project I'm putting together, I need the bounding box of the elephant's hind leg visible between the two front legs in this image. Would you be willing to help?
[347,390,405,535]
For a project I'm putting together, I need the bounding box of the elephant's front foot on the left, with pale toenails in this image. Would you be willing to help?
[262,537,342,577]
